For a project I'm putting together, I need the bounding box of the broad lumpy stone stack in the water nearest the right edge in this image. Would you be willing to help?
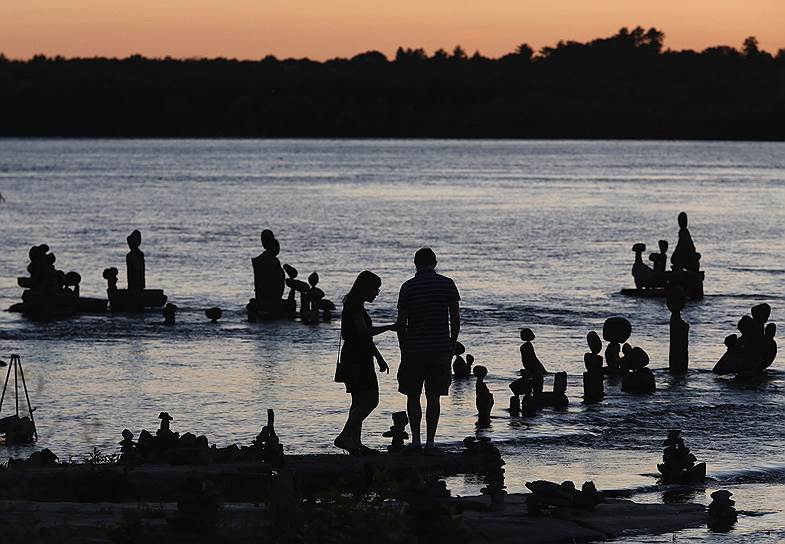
[712,303,777,379]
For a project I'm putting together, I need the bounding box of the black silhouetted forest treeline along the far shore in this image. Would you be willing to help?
[0,28,785,140]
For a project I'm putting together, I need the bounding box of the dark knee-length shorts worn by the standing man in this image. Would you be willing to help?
[398,351,452,397]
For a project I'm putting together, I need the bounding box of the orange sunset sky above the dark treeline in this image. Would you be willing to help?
[0,0,785,60]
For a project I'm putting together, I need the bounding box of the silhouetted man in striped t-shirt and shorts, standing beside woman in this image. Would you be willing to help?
[397,248,461,452]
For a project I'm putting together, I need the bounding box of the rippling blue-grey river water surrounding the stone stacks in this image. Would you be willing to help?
[0,140,785,542]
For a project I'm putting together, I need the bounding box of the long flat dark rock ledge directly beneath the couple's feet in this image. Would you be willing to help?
[0,452,499,502]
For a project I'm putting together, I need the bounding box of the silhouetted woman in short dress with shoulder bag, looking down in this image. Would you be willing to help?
[334,270,395,455]
